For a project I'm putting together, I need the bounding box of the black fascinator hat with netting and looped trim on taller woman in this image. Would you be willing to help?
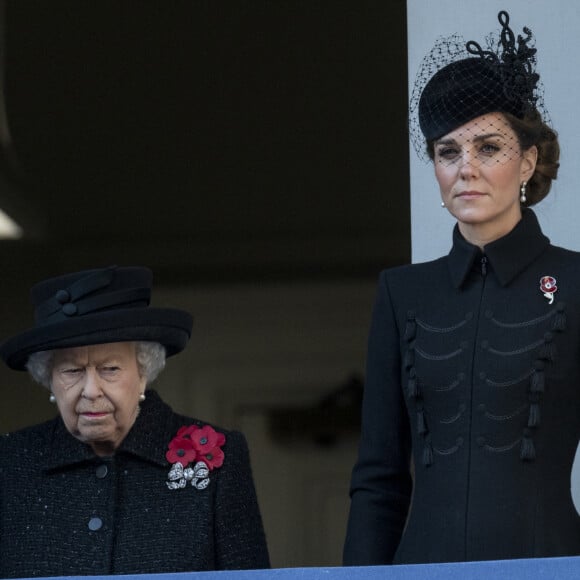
[410,11,547,157]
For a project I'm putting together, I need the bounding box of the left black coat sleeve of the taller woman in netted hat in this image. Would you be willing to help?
[343,272,412,566]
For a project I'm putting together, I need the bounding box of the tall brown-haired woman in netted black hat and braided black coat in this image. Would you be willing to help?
[344,12,580,565]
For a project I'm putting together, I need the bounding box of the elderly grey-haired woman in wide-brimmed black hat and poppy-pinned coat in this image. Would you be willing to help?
[0,267,269,578]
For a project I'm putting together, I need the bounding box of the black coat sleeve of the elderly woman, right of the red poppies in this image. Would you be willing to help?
[214,431,270,570]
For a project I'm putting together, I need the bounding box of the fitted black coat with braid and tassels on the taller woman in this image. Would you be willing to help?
[344,210,580,565]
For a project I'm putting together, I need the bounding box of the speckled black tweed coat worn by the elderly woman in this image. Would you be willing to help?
[0,391,269,578]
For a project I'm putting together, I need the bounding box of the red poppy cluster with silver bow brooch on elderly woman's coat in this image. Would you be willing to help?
[165,425,226,489]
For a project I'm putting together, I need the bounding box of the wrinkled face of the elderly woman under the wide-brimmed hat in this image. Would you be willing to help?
[52,342,146,455]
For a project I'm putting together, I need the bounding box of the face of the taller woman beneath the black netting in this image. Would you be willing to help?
[433,113,537,247]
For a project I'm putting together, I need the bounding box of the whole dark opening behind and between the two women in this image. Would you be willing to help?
[0,0,410,567]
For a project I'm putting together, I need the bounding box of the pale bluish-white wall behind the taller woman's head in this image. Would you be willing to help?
[407,0,580,262]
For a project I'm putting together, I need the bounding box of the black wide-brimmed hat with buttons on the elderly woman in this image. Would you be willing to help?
[0,266,193,370]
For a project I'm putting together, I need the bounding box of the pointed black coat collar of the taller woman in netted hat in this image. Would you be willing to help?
[448,209,550,288]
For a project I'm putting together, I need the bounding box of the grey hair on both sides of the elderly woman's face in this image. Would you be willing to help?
[26,341,166,389]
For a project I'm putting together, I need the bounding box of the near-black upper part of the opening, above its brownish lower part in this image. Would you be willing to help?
[0,0,410,283]
